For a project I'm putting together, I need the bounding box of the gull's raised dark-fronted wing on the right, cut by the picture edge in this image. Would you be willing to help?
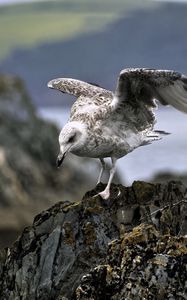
[113,68,187,129]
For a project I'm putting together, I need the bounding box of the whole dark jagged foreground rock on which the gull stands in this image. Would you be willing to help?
[0,182,187,300]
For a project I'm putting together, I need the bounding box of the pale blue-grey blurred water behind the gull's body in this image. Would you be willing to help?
[39,108,187,184]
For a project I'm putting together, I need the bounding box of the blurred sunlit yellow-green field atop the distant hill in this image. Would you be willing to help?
[0,0,153,61]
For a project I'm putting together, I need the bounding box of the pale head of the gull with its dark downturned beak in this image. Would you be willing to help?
[57,122,87,168]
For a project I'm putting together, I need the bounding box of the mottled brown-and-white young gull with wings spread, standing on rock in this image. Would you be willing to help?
[48,68,187,199]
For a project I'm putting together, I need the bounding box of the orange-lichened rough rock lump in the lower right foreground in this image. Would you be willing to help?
[76,224,187,300]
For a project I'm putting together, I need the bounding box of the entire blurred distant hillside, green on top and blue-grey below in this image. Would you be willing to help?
[0,0,187,107]
